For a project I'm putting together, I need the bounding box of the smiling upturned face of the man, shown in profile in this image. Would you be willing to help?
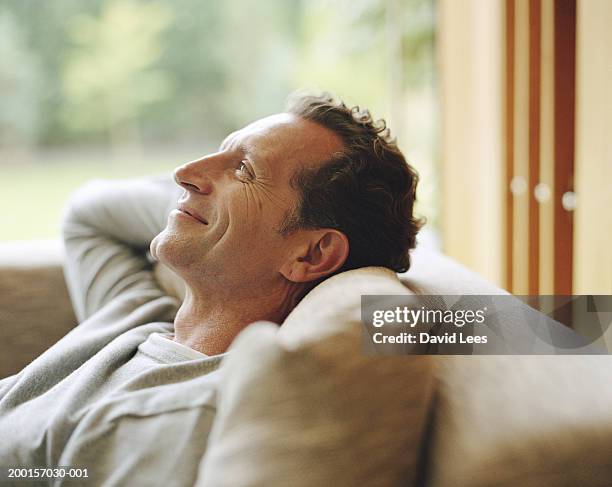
[151,113,343,289]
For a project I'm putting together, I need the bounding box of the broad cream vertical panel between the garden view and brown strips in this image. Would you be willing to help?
[438,0,504,286]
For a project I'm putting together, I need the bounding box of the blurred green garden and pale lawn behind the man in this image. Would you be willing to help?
[0,0,438,240]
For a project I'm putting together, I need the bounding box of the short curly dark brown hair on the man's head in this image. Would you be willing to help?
[281,93,422,272]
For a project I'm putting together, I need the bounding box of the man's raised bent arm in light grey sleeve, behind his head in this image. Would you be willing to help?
[62,177,182,322]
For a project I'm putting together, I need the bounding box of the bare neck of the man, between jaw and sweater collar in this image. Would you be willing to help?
[174,286,299,355]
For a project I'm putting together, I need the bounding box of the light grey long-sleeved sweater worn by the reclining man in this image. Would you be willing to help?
[0,178,222,486]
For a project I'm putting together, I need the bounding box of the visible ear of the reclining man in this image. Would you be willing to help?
[280,228,349,282]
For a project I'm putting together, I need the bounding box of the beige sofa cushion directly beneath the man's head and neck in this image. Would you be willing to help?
[199,268,433,487]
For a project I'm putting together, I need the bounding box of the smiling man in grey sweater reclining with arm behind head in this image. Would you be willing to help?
[0,92,419,485]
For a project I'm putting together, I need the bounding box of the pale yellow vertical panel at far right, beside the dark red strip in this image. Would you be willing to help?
[573,0,612,294]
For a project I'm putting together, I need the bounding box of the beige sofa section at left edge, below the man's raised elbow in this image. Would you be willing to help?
[0,241,76,378]
